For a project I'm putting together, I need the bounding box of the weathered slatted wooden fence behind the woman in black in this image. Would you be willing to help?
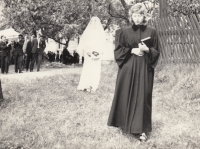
[149,15,200,63]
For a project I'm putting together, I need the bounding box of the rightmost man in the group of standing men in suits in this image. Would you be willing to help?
[37,34,46,71]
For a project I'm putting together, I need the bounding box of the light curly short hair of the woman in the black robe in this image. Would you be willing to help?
[129,3,150,25]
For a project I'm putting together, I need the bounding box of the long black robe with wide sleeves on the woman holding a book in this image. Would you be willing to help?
[108,25,160,134]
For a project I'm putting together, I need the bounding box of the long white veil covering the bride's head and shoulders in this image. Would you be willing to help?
[77,17,106,55]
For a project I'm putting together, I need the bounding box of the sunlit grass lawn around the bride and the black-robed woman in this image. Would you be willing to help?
[0,63,200,149]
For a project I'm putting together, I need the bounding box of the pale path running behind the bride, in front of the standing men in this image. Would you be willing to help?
[0,67,82,80]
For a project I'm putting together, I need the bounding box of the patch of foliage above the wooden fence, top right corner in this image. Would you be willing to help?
[168,0,200,16]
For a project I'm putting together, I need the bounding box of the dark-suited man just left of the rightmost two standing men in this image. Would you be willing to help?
[23,35,32,71]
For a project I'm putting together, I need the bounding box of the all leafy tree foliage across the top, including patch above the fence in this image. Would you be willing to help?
[0,0,200,45]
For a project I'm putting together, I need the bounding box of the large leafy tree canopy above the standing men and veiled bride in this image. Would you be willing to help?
[0,0,110,44]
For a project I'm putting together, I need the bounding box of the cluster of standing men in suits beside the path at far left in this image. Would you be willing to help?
[0,34,46,74]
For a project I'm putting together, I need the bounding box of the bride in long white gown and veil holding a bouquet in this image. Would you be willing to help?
[77,17,106,91]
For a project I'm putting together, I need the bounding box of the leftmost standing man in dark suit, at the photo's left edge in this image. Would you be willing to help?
[0,36,10,74]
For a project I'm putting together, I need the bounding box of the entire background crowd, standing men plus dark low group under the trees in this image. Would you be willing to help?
[0,34,84,74]
